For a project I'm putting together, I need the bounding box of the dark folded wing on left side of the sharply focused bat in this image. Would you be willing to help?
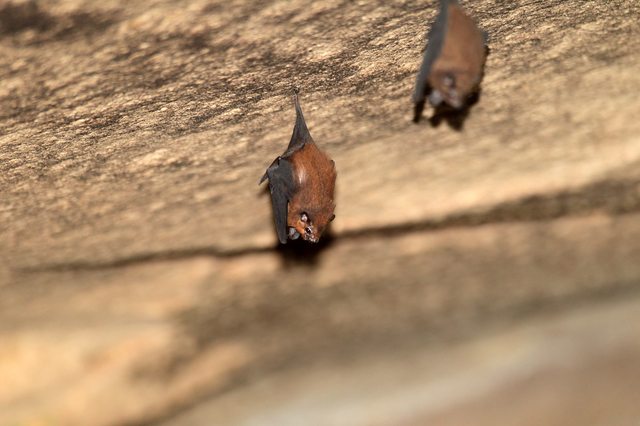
[260,157,294,244]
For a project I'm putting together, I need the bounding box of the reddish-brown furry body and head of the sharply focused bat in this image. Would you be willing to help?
[287,142,336,241]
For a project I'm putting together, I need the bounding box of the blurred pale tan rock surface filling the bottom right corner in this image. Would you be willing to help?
[162,300,640,426]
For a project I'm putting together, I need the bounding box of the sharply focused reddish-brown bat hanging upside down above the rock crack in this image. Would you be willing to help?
[258,90,337,244]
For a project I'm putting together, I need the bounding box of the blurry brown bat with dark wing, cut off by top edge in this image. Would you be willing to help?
[413,0,487,109]
